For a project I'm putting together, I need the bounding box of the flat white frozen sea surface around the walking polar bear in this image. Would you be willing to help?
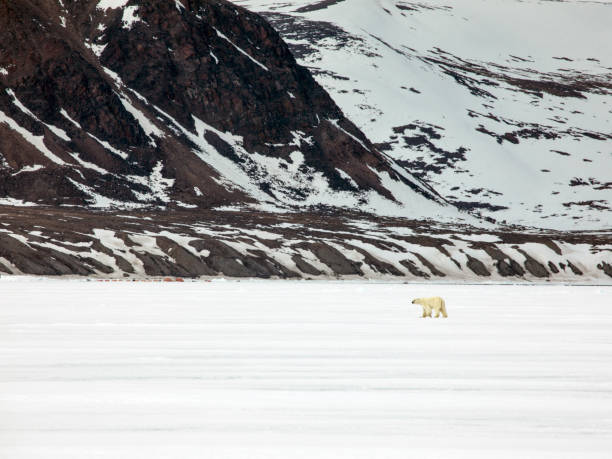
[0,281,612,459]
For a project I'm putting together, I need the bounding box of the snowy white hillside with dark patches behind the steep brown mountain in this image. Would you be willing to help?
[236,0,612,229]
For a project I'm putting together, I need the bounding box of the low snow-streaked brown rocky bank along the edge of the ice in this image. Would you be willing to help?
[0,207,612,284]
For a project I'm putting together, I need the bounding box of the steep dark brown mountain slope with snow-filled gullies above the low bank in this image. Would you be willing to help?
[0,0,435,212]
